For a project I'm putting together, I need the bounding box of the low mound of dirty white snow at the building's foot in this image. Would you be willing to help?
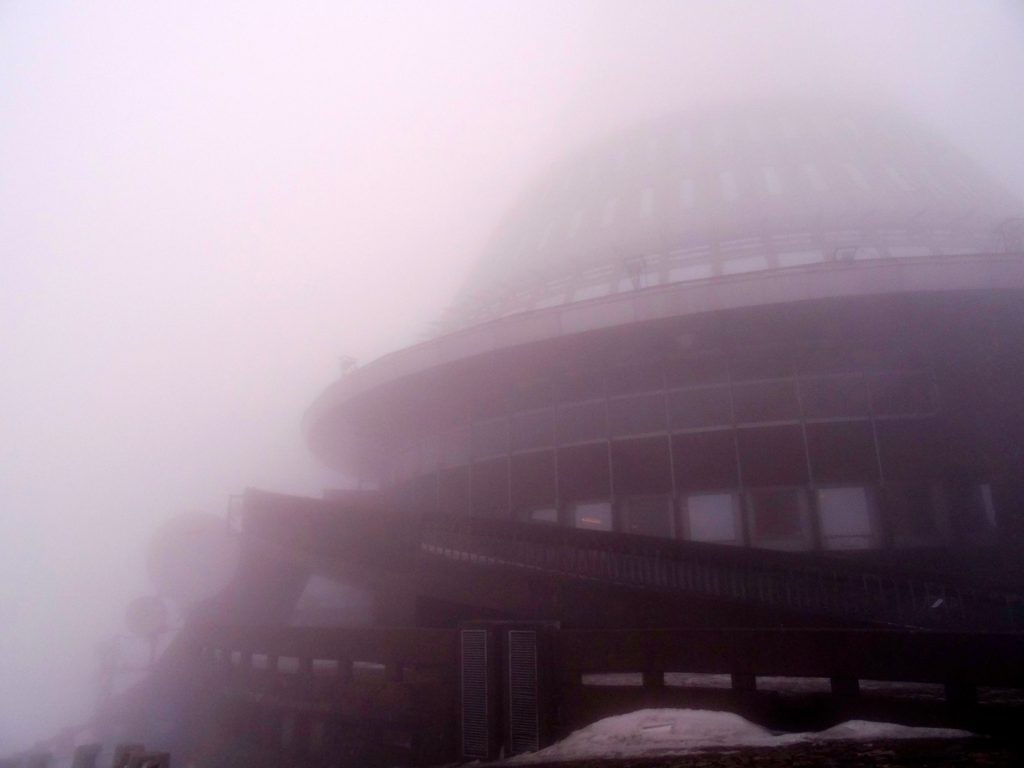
[508,710,973,764]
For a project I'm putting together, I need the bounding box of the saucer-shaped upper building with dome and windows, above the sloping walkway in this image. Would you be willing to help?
[305,105,1024,552]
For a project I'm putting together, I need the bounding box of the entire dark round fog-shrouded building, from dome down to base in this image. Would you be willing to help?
[92,104,1024,765]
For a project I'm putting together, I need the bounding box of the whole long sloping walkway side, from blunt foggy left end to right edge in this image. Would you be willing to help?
[235,489,1024,631]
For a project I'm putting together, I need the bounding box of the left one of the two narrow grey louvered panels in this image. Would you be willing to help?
[459,628,498,760]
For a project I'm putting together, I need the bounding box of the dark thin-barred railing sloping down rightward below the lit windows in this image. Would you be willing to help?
[420,517,1024,630]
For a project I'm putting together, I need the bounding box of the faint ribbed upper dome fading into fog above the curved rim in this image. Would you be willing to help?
[441,104,1022,332]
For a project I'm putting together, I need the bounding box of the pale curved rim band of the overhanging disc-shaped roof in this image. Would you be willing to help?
[303,253,1024,473]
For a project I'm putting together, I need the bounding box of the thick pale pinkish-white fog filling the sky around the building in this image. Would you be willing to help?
[0,0,1024,753]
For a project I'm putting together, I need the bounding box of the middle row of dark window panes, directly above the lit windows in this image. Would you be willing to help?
[395,419,986,536]
